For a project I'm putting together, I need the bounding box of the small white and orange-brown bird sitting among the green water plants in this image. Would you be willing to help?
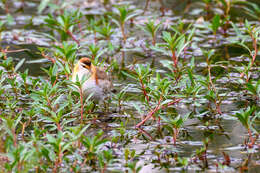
[72,57,112,102]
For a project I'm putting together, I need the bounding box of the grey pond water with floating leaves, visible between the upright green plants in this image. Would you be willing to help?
[0,0,260,173]
